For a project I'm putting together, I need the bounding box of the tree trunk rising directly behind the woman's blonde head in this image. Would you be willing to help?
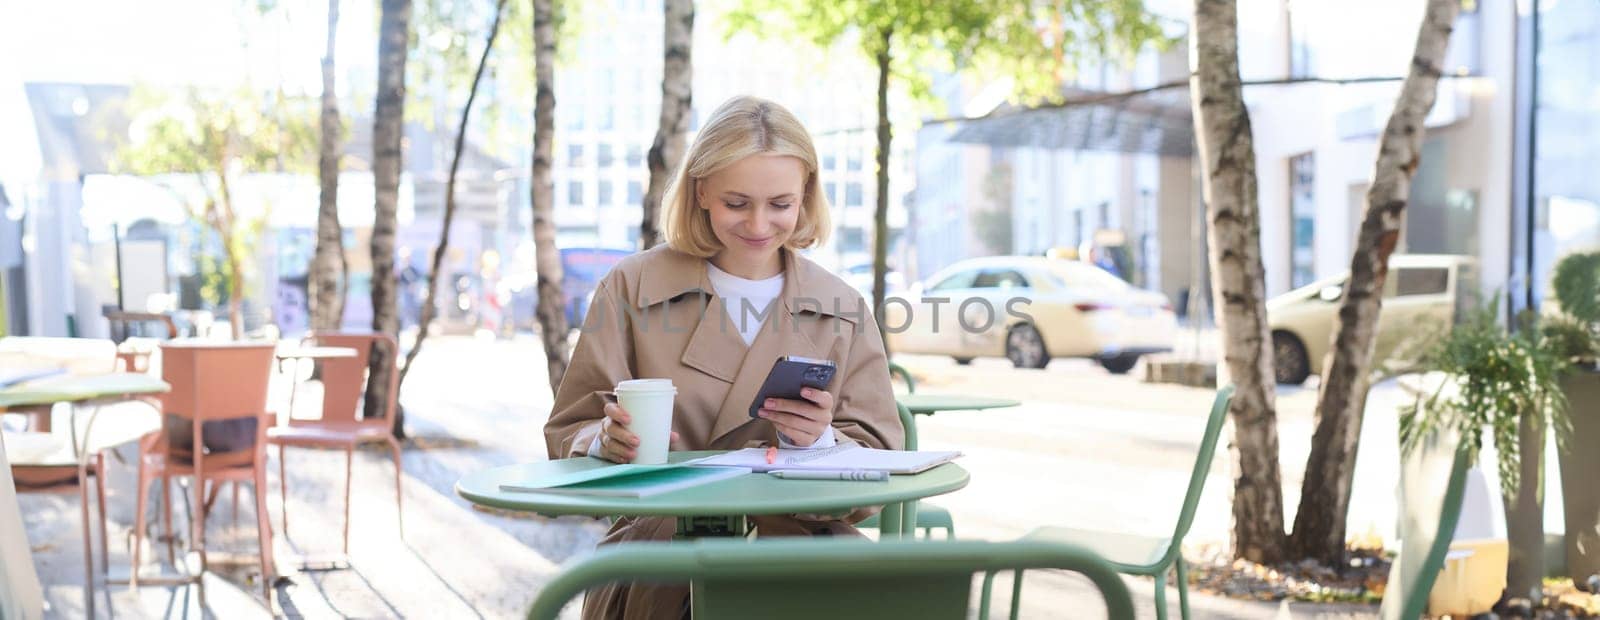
[638,0,694,249]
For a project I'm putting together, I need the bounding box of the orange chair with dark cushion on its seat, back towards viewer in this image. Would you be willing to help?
[131,342,275,609]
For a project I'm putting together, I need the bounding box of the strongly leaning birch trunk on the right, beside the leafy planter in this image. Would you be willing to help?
[1290,0,1461,566]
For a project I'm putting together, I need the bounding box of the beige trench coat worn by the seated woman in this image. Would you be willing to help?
[544,246,906,618]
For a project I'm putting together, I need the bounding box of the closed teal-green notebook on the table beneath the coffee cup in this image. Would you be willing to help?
[501,463,750,497]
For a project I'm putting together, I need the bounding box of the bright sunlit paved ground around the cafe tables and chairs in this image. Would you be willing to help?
[22,337,1397,618]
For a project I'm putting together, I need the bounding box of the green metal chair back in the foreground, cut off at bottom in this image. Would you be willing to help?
[528,539,1133,620]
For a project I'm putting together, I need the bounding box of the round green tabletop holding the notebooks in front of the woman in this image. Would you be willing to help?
[456,451,968,537]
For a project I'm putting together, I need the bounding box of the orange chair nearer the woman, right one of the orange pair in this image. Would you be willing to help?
[267,334,405,554]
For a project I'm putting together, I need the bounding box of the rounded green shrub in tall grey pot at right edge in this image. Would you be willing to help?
[1546,252,1600,588]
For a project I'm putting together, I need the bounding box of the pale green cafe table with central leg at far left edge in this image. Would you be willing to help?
[0,372,171,617]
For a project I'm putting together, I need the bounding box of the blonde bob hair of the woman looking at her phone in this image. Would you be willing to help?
[661,96,834,257]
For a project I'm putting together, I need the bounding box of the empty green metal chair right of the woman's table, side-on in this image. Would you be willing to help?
[984,385,1234,620]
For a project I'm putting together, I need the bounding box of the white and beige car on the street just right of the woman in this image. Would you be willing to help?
[883,256,1178,374]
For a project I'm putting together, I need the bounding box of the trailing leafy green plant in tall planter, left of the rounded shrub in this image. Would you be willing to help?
[1400,297,1568,599]
